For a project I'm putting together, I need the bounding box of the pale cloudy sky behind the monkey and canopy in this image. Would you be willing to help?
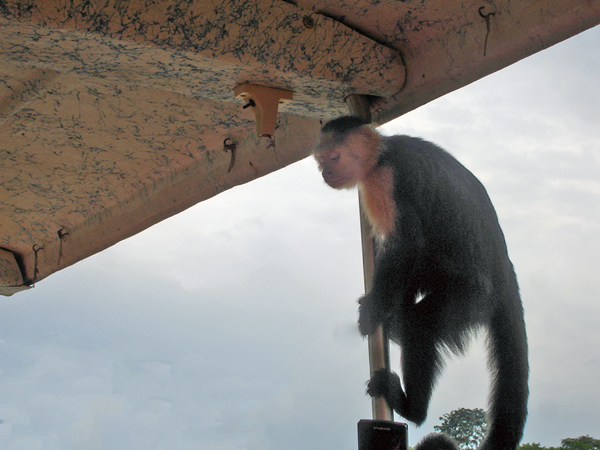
[0,23,600,450]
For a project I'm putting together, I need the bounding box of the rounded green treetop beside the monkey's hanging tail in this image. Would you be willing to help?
[433,408,488,450]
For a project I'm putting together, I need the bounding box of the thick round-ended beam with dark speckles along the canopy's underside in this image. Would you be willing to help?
[0,0,404,116]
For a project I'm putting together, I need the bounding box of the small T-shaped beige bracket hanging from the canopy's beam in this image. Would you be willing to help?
[233,84,294,137]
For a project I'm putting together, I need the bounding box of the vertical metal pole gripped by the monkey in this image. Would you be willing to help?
[346,95,394,421]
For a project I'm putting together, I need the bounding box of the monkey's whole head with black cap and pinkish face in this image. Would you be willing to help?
[313,116,381,189]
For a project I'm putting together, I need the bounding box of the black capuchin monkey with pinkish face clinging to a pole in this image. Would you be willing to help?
[314,116,529,450]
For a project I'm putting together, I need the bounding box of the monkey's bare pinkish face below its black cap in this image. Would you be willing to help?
[313,133,363,189]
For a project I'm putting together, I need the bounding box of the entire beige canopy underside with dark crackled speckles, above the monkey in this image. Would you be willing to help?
[0,0,600,295]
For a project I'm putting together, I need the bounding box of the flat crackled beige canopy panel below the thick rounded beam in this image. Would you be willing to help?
[0,66,319,292]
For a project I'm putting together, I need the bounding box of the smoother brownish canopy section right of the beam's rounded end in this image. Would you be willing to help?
[297,0,600,124]
